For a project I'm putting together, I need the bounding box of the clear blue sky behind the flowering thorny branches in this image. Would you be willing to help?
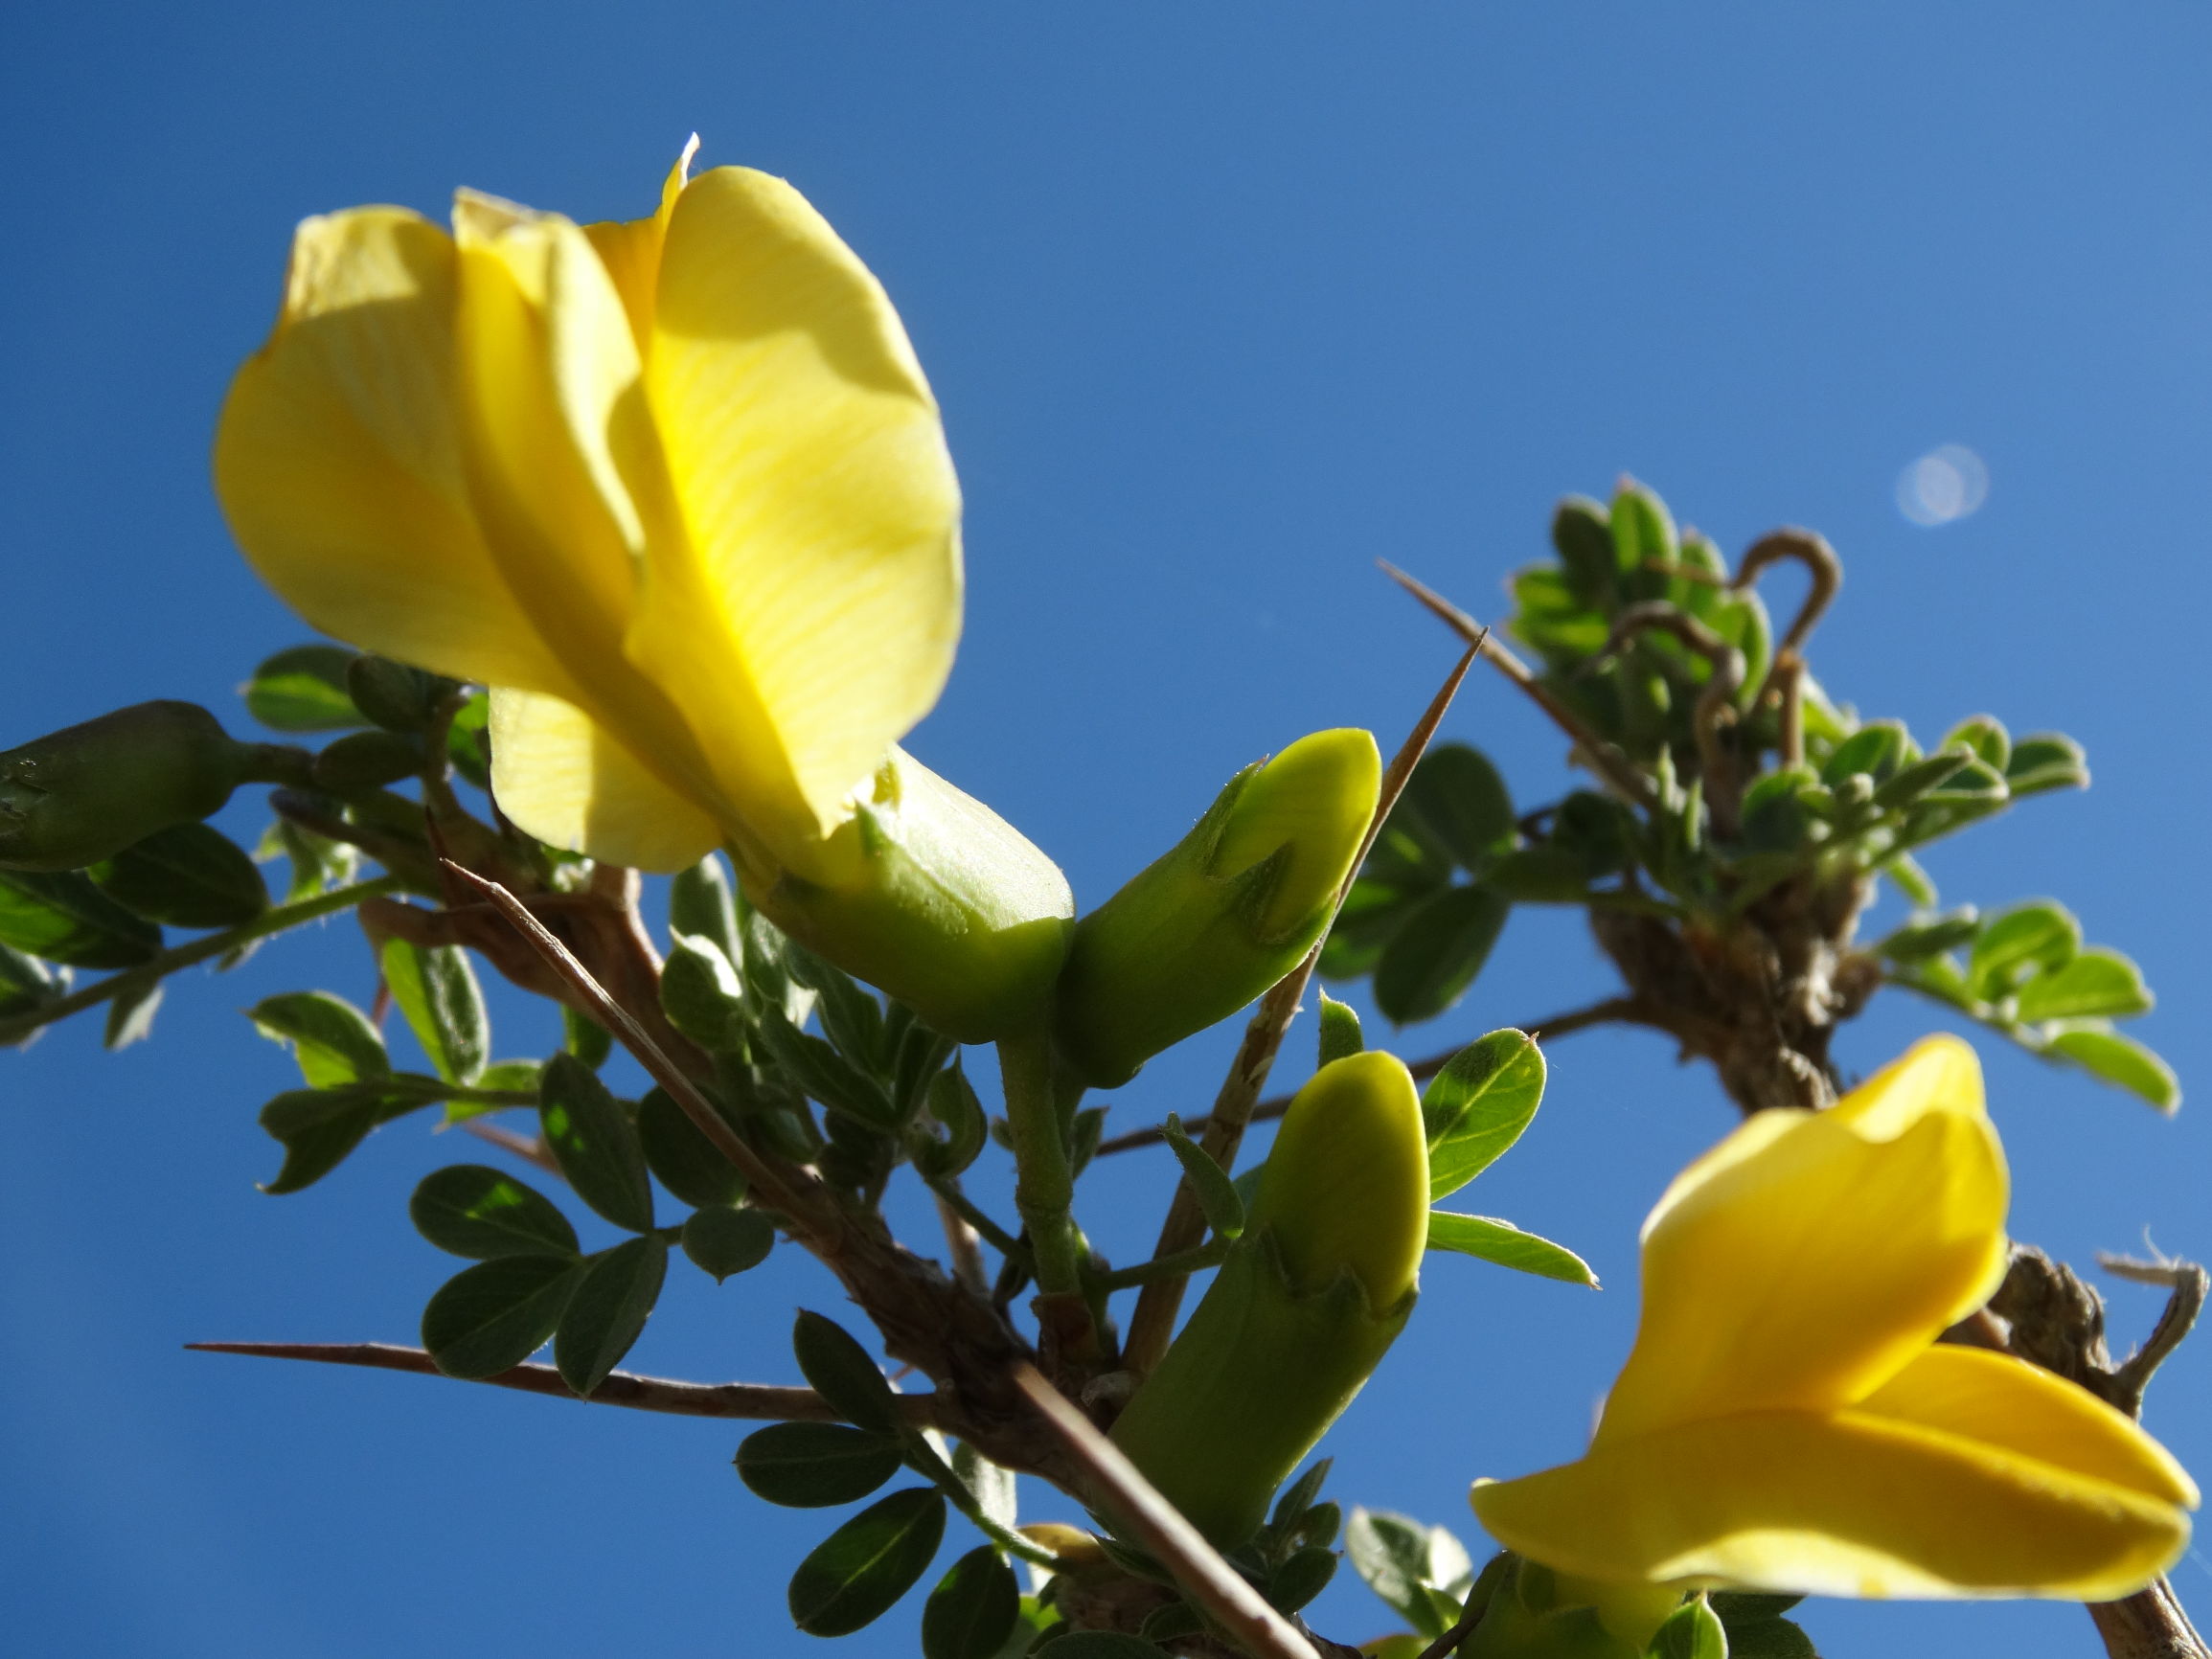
[0,0,2212,1659]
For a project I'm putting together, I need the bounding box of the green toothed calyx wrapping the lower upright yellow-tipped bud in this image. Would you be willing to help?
[1112,1230,1418,1549]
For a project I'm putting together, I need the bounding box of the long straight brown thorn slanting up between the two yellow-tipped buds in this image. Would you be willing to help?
[1122,628,1489,1378]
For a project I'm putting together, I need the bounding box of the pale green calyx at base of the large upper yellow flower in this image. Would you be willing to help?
[745,750,1075,1042]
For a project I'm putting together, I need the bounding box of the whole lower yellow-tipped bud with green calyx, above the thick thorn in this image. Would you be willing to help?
[1112,1053,1429,1549]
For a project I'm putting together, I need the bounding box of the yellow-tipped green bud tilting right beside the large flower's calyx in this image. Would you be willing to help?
[1055,730,1382,1088]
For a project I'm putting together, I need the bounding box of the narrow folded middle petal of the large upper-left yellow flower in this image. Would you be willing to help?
[453,193,730,835]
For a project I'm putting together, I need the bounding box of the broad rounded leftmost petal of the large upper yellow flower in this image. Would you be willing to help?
[215,208,566,691]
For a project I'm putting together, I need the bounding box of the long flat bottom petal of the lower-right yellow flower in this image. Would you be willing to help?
[1473,1411,2190,1602]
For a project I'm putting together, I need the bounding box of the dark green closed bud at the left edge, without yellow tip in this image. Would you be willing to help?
[0,701,255,870]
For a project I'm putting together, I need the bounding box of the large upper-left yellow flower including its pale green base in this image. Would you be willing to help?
[215,139,1073,1035]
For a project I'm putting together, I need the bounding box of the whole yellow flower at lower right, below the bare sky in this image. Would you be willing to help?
[1473,1037,2197,1602]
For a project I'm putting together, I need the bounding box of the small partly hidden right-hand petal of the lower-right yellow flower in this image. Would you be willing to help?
[1854,1345,2197,1509]
